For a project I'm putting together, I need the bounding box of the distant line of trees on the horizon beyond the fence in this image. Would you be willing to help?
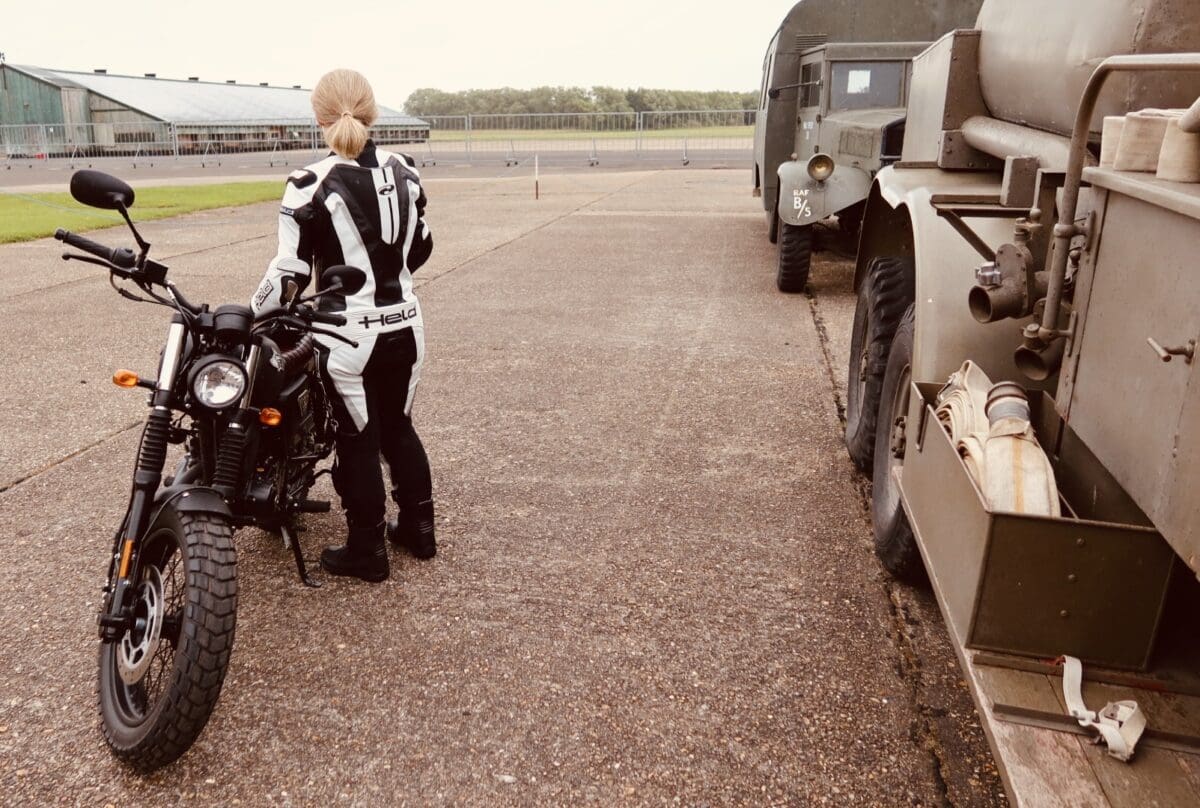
[404,86,758,115]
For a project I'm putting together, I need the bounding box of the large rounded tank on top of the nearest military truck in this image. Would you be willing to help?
[976,0,1200,134]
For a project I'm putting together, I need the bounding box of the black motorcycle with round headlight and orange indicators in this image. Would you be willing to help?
[54,170,359,771]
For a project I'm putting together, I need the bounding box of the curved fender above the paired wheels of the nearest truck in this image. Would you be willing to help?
[854,166,1044,388]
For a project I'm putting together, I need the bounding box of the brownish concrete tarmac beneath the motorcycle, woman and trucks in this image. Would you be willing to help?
[0,169,1002,806]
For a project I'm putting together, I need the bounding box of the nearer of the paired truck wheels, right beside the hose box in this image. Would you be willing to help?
[871,306,928,583]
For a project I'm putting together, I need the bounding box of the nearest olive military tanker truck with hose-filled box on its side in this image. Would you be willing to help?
[846,0,1200,806]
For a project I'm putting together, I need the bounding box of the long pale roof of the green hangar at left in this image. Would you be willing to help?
[5,65,425,126]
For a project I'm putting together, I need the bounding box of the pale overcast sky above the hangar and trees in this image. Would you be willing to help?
[7,0,793,108]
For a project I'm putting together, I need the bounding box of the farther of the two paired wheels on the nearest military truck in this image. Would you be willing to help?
[846,256,914,472]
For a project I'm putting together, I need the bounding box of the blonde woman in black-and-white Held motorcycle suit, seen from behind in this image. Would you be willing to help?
[251,70,437,581]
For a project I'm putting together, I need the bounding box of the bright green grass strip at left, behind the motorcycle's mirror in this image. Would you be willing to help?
[0,180,283,244]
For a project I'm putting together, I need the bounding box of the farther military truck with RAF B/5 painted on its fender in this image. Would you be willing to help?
[754,0,980,292]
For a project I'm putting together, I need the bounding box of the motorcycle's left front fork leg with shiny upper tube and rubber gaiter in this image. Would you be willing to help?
[98,315,187,642]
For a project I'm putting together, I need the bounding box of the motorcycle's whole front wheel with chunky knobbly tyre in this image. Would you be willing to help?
[100,505,238,772]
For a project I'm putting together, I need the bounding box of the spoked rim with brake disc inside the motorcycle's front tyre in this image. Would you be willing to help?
[109,529,187,726]
